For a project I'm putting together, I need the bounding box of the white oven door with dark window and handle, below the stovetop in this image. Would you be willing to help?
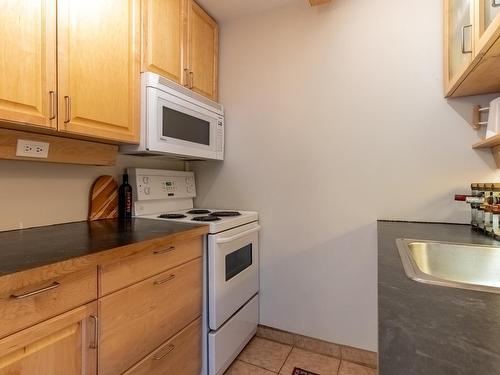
[208,222,260,330]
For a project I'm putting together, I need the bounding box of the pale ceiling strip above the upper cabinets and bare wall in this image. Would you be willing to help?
[197,0,297,22]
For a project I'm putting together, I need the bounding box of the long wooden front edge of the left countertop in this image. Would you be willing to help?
[0,225,209,295]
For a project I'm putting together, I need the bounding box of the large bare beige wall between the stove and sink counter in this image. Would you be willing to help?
[196,0,499,350]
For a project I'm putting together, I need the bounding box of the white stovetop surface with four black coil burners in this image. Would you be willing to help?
[139,208,259,233]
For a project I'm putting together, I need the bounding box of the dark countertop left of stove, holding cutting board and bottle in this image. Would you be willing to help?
[0,219,208,276]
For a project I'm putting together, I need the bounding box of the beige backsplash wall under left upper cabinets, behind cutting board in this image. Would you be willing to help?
[0,156,184,231]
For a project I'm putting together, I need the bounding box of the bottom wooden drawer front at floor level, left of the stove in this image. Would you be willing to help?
[125,318,201,375]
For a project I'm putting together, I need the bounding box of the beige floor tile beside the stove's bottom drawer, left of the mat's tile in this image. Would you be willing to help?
[238,337,292,372]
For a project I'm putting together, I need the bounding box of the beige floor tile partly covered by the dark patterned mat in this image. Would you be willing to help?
[280,348,340,375]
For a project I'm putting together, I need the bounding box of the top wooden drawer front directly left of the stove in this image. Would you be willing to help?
[99,237,203,296]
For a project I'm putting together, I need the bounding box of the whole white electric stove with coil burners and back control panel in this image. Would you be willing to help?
[128,168,260,375]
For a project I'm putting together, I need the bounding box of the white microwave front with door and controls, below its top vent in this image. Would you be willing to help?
[147,87,224,159]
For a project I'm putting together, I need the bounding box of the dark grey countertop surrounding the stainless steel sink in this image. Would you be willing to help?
[378,221,500,375]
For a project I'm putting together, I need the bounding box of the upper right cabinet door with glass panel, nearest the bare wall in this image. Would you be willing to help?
[444,0,474,94]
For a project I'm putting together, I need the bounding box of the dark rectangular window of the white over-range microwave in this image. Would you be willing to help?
[163,107,210,146]
